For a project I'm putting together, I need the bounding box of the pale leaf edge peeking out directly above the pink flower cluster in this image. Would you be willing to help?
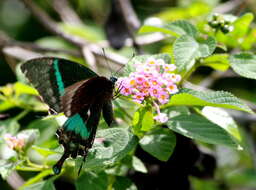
[124,53,171,76]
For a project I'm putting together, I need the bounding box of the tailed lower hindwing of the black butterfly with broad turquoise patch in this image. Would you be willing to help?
[53,105,102,174]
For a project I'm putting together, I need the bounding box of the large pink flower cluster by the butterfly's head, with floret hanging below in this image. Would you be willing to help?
[118,58,181,122]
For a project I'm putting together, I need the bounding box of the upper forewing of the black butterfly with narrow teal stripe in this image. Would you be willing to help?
[21,57,97,112]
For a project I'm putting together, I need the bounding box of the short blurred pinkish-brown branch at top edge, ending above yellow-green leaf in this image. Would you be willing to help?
[52,0,83,25]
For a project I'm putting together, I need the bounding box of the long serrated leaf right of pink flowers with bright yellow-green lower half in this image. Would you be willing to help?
[167,88,253,113]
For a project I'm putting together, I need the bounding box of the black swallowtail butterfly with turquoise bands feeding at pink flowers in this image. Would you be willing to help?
[21,57,117,174]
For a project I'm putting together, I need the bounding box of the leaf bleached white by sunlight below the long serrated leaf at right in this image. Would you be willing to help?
[202,106,242,142]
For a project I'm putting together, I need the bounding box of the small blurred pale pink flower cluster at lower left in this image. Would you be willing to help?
[4,133,26,150]
